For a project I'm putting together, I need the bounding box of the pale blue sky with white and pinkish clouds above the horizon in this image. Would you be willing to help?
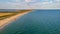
[0,0,60,9]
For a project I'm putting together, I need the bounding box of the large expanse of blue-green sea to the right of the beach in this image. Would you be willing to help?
[0,10,60,34]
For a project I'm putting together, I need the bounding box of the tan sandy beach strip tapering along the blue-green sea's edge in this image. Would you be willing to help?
[0,11,31,29]
